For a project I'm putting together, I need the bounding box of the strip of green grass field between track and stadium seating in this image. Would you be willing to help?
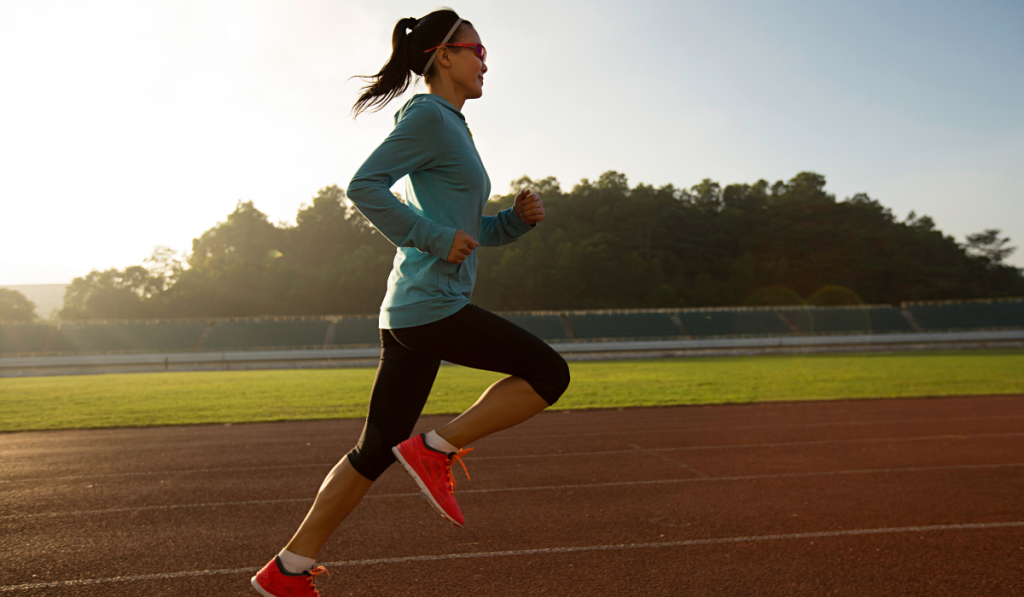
[0,349,1024,431]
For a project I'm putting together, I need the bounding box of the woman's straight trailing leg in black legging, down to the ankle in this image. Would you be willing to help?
[286,330,440,558]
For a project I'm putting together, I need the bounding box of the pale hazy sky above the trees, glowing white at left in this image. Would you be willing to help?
[0,0,1024,286]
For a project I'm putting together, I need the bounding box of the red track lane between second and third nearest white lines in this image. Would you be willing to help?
[0,434,1024,518]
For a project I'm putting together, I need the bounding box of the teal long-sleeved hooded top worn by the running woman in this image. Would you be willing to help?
[347,94,534,329]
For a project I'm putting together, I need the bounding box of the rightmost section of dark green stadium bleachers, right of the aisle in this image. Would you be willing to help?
[903,299,1024,332]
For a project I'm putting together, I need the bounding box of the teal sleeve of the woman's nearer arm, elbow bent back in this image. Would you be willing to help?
[347,104,456,259]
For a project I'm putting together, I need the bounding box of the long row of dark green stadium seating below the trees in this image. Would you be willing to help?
[0,299,1024,354]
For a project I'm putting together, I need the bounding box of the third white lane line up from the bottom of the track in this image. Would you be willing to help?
[0,432,1024,483]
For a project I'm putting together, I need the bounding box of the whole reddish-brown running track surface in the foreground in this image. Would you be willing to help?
[0,396,1024,597]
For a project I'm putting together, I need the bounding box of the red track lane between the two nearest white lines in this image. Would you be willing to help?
[2,452,1024,585]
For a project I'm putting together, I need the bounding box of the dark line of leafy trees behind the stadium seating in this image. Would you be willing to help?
[44,171,1024,319]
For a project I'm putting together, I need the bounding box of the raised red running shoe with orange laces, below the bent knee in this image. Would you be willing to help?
[391,433,473,526]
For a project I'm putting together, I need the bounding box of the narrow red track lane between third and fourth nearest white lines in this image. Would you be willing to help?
[0,409,1024,483]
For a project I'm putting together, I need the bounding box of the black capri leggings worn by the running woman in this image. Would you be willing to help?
[348,305,569,480]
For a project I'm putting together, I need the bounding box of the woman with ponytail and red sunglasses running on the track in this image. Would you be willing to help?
[252,10,569,597]
